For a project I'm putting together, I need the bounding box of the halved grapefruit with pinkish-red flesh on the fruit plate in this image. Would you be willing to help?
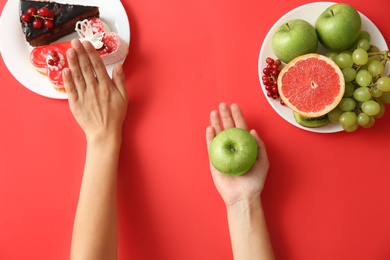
[278,53,345,117]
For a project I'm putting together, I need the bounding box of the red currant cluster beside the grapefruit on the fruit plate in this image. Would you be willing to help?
[262,57,284,105]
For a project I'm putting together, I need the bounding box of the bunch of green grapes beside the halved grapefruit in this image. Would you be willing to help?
[327,31,390,132]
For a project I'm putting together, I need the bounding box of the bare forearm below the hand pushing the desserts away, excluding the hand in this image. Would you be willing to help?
[71,136,121,260]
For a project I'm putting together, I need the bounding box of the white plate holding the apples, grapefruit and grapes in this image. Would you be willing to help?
[258,2,390,133]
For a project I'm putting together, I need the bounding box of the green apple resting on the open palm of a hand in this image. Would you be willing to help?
[209,128,258,176]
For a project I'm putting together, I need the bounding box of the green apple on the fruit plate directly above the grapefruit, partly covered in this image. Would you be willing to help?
[272,19,318,63]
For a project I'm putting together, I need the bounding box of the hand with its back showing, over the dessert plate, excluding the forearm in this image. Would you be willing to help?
[63,40,128,139]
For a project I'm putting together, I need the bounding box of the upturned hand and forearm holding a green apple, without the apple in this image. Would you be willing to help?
[206,103,274,260]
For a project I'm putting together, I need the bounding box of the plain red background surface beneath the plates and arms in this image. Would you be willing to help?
[0,0,390,260]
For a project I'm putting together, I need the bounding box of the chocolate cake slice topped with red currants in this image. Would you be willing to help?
[19,0,100,47]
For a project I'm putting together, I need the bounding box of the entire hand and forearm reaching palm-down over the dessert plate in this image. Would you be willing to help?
[63,40,128,260]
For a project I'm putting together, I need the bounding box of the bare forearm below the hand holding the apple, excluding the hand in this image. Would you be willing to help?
[227,198,274,260]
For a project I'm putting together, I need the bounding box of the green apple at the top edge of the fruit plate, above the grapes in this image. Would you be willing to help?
[315,4,362,52]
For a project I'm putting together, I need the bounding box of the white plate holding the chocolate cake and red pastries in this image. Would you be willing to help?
[0,0,130,99]
